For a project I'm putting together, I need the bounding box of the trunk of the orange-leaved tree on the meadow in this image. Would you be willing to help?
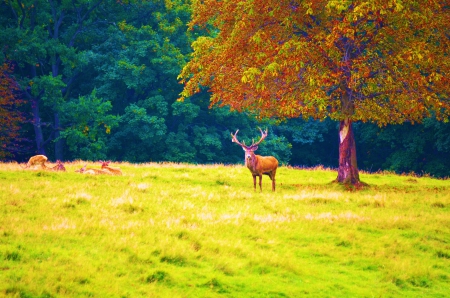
[336,119,361,185]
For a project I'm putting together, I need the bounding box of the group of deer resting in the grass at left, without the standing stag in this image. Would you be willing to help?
[22,155,122,175]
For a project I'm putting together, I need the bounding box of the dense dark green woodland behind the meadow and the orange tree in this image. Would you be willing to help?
[0,0,450,177]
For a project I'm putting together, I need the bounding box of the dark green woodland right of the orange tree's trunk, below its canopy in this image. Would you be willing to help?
[355,118,450,177]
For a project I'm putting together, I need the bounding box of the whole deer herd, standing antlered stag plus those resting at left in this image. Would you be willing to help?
[25,128,278,191]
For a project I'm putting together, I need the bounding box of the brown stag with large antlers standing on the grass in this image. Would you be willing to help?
[231,127,278,191]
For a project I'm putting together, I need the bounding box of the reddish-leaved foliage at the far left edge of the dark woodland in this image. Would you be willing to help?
[0,63,25,159]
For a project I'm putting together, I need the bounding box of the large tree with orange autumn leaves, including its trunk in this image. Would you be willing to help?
[180,0,450,185]
